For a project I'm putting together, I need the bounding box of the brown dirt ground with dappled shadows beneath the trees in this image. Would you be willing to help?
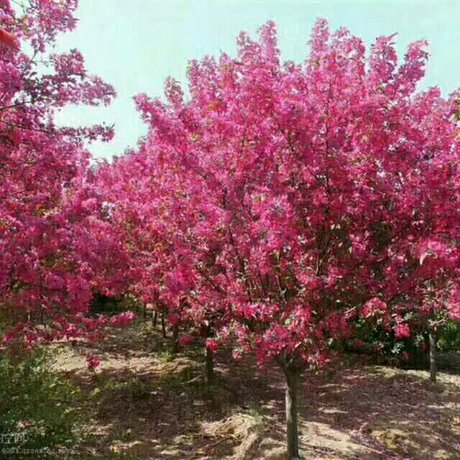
[55,322,460,460]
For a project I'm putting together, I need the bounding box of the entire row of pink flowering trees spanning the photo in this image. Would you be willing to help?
[0,0,460,458]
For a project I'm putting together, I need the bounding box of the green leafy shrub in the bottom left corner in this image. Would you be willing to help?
[0,350,83,458]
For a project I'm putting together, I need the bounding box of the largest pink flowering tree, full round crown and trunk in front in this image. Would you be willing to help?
[115,20,460,458]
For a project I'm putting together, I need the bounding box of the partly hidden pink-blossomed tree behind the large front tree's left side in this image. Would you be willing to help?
[97,139,228,381]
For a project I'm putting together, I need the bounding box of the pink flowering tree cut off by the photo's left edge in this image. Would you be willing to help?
[0,0,131,347]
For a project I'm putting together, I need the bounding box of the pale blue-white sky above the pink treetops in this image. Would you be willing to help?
[57,0,460,159]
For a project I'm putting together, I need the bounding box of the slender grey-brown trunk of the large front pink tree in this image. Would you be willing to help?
[284,367,300,460]
